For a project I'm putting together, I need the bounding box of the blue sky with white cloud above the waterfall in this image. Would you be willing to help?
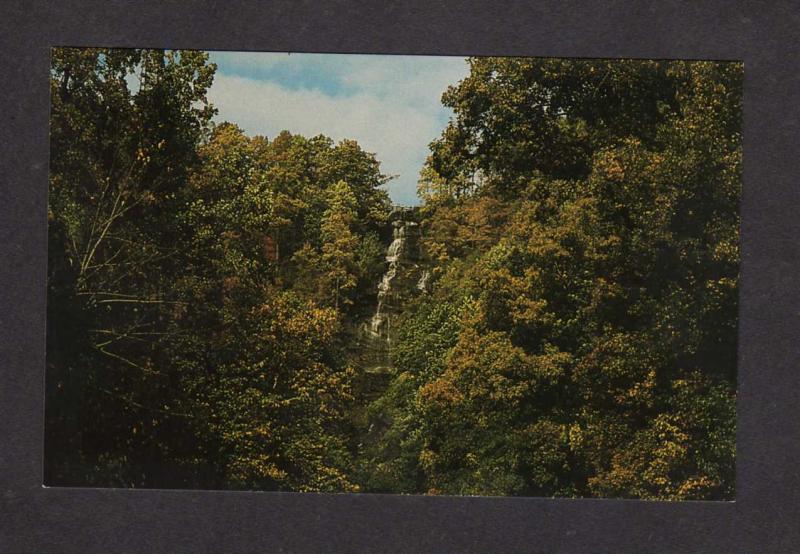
[208,52,469,206]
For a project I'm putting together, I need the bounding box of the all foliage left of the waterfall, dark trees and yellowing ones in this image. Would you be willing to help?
[46,49,390,491]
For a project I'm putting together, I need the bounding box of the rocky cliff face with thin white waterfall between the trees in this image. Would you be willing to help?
[362,209,430,373]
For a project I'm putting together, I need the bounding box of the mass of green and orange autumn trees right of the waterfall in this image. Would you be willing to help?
[372,58,742,500]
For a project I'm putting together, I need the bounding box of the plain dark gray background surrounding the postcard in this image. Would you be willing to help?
[0,0,800,552]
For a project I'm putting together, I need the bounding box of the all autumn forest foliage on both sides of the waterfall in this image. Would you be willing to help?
[45,49,742,499]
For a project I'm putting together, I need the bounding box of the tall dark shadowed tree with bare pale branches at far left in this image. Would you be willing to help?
[46,48,220,485]
